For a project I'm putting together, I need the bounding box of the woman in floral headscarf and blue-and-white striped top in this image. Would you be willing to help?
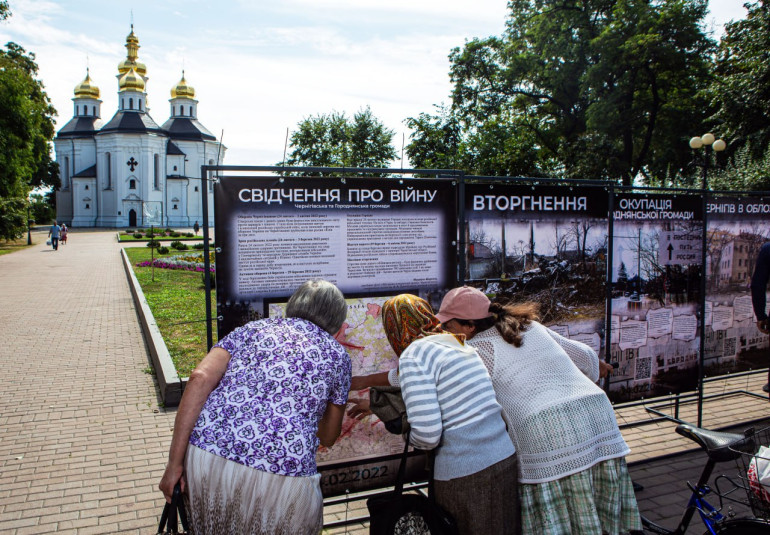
[382,294,518,535]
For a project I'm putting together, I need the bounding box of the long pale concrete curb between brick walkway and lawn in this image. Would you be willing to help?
[120,249,187,407]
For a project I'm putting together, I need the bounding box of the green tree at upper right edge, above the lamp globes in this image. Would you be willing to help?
[708,0,770,160]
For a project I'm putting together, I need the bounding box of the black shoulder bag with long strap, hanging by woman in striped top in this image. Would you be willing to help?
[366,436,458,535]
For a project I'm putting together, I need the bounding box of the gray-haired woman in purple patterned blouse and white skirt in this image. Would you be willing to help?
[159,281,351,535]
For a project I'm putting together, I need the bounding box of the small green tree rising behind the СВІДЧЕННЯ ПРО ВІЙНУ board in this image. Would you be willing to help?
[279,107,396,174]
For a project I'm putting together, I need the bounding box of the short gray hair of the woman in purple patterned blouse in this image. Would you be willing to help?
[286,280,348,334]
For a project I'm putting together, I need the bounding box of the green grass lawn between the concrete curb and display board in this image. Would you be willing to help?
[126,247,217,377]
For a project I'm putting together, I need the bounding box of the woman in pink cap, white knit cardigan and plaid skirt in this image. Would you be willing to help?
[436,287,641,535]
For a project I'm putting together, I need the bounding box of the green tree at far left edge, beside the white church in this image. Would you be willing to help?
[0,40,59,240]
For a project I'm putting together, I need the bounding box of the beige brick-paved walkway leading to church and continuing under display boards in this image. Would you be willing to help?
[0,230,770,535]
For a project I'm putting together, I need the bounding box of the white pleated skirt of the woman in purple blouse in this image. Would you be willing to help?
[185,445,323,535]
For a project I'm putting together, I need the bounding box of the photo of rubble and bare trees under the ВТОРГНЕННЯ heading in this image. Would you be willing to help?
[465,214,607,354]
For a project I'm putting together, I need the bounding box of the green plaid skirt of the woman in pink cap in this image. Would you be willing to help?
[519,458,642,535]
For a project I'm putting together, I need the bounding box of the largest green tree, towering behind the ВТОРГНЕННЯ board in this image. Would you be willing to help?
[450,0,714,184]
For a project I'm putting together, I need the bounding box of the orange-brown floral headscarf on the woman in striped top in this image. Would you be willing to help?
[382,294,465,357]
